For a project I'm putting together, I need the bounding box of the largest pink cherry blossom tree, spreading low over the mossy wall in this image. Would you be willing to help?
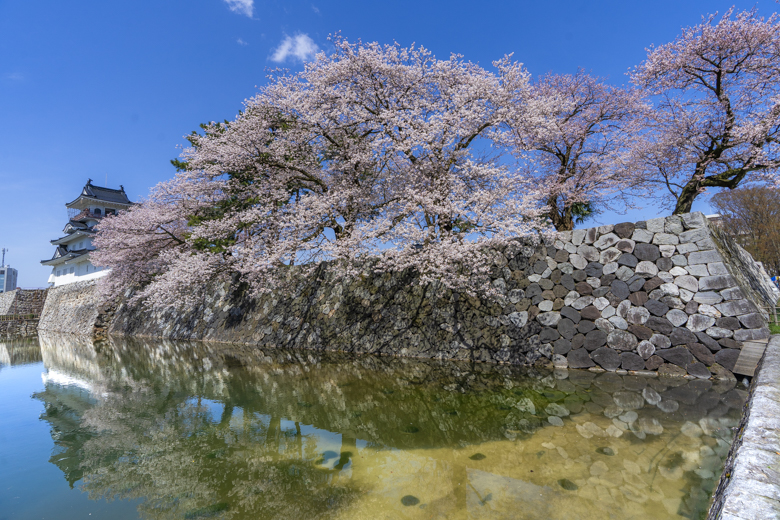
[95,38,551,306]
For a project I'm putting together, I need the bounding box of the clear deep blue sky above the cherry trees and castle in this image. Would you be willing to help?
[0,0,778,287]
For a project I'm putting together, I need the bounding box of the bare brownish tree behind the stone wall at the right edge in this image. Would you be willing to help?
[711,186,780,276]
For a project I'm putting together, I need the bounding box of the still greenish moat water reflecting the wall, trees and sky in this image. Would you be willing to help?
[0,335,746,520]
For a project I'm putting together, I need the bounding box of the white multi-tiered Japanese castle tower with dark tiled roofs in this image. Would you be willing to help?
[41,179,133,287]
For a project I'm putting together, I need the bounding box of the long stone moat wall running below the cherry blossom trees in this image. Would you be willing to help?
[85,213,774,378]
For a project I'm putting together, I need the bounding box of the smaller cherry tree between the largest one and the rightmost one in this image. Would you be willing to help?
[517,70,647,231]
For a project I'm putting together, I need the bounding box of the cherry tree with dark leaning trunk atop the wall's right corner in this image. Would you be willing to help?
[631,8,780,214]
